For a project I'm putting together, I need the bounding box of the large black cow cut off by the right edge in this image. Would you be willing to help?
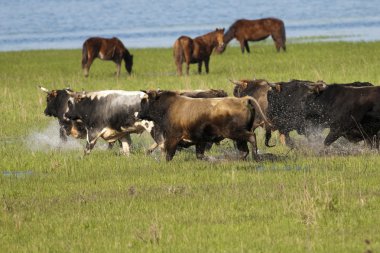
[305,84,380,148]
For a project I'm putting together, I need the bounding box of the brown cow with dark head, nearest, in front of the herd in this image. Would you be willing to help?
[138,91,269,161]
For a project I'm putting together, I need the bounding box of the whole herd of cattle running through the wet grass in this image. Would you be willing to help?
[40,80,380,161]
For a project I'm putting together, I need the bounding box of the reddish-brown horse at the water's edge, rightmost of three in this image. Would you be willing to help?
[221,18,286,53]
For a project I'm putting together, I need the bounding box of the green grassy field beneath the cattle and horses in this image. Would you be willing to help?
[0,42,380,252]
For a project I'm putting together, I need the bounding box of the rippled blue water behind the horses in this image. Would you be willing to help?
[0,0,380,51]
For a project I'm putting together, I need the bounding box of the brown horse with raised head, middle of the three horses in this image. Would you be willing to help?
[173,28,224,75]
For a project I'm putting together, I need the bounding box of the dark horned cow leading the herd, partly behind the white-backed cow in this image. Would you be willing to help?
[39,86,86,141]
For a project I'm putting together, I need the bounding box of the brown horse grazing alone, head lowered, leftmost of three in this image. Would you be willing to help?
[82,37,133,77]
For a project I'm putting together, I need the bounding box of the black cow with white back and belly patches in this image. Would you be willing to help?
[64,90,153,155]
